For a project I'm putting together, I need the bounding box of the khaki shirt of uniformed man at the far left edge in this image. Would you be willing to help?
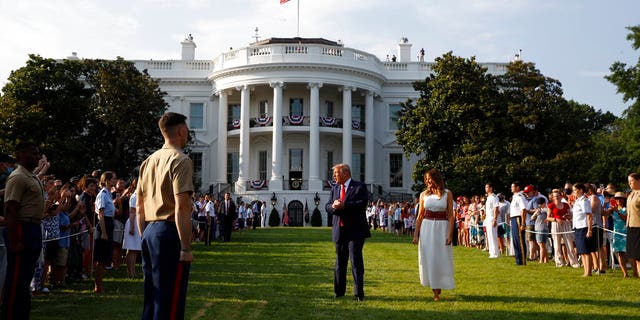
[4,165,44,223]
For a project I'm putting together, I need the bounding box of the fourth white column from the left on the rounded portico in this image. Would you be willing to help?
[309,82,322,191]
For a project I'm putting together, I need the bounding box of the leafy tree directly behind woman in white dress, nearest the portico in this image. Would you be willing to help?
[396,52,499,195]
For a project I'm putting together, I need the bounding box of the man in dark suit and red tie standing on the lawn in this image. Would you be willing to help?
[325,164,371,301]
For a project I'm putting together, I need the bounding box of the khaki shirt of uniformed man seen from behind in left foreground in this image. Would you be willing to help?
[136,144,194,221]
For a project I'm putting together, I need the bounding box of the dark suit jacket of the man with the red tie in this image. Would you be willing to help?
[325,179,371,242]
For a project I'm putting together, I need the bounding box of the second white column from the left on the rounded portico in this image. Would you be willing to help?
[236,85,251,193]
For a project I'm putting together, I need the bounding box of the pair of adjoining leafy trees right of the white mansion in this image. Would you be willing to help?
[396,52,615,194]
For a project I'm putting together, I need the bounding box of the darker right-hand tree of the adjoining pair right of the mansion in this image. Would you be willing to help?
[499,61,616,188]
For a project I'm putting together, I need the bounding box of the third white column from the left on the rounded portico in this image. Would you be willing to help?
[269,81,284,191]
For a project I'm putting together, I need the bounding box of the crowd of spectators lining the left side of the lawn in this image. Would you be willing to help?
[0,153,267,302]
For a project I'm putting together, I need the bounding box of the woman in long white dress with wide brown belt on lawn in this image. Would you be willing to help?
[413,169,455,301]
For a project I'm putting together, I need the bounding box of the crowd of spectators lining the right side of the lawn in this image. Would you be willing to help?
[367,182,638,277]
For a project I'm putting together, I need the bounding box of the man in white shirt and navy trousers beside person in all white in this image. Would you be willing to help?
[509,182,527,266]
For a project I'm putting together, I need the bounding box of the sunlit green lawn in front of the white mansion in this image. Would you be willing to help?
[32,228,640,320]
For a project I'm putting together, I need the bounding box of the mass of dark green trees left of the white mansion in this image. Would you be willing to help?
[0,55,167,178]
